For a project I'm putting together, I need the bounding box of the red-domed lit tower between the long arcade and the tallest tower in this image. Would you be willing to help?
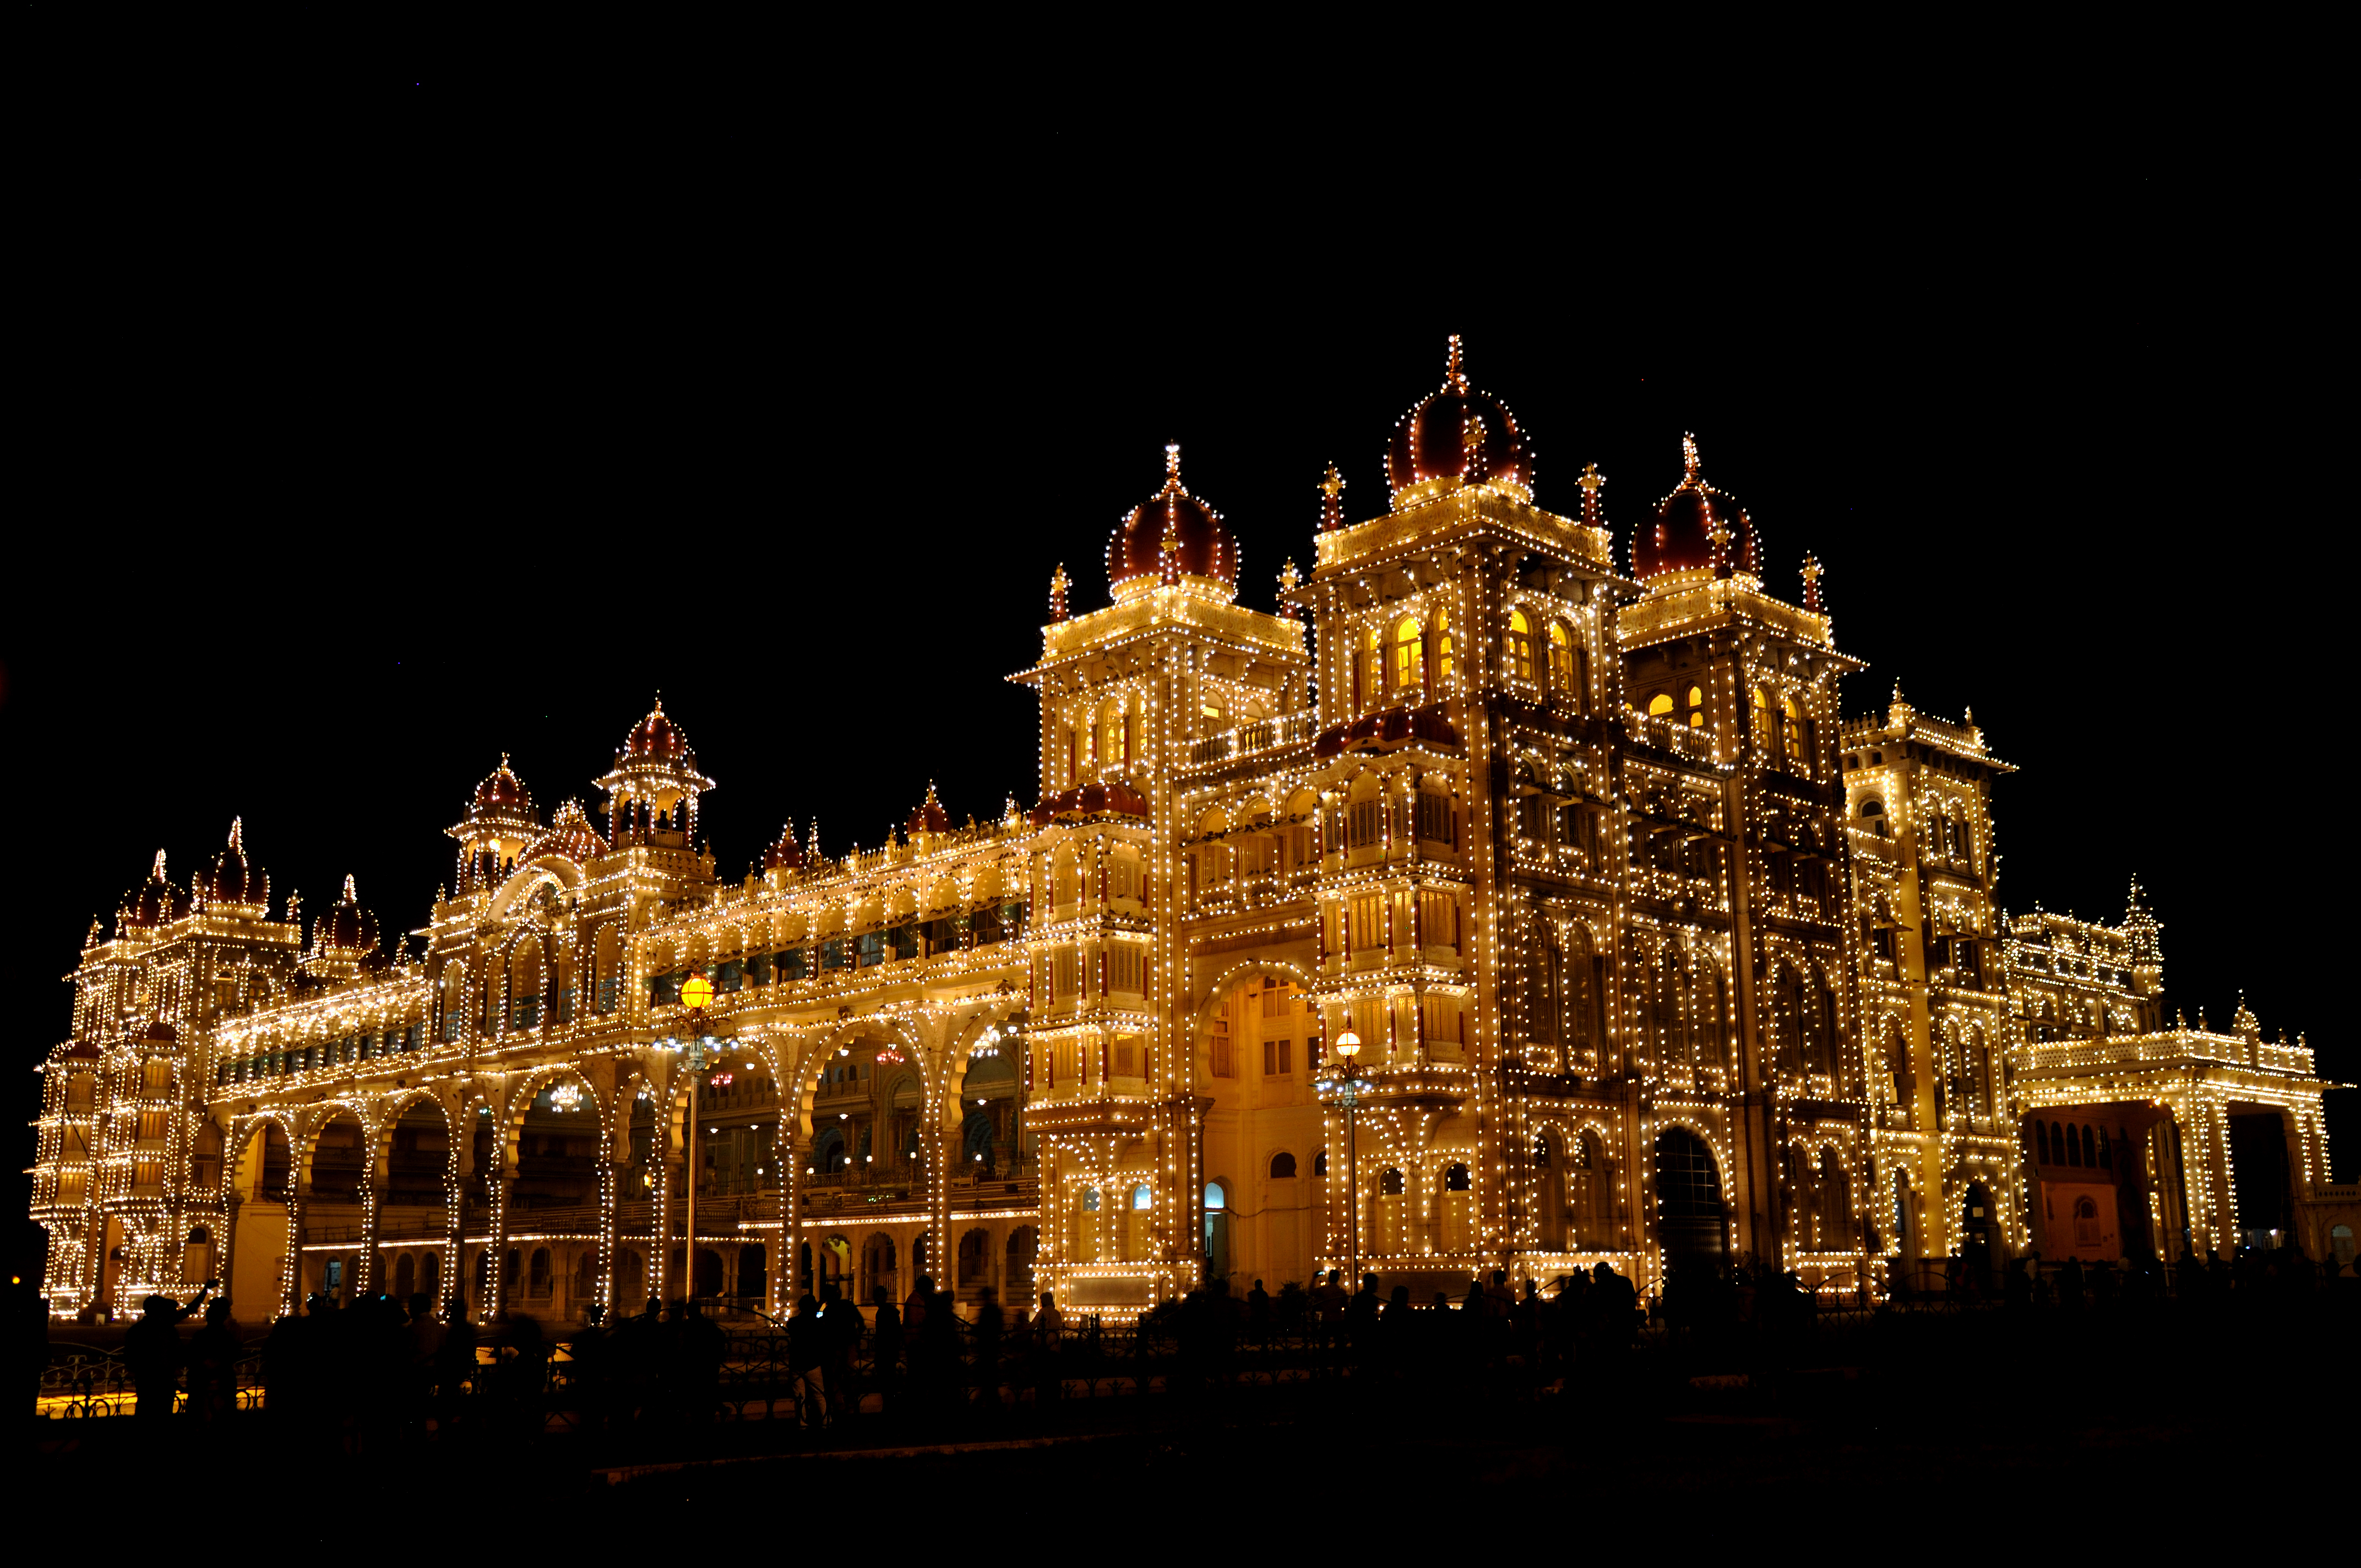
[1010,447,1310,1308]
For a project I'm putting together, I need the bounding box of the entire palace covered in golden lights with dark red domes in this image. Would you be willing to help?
[33,340,2333,1320]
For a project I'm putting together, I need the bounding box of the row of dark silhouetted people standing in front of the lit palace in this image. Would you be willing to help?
[32,1247,2361,1455]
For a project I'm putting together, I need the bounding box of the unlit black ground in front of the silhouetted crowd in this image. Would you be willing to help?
[32,1310,2361,1561]
